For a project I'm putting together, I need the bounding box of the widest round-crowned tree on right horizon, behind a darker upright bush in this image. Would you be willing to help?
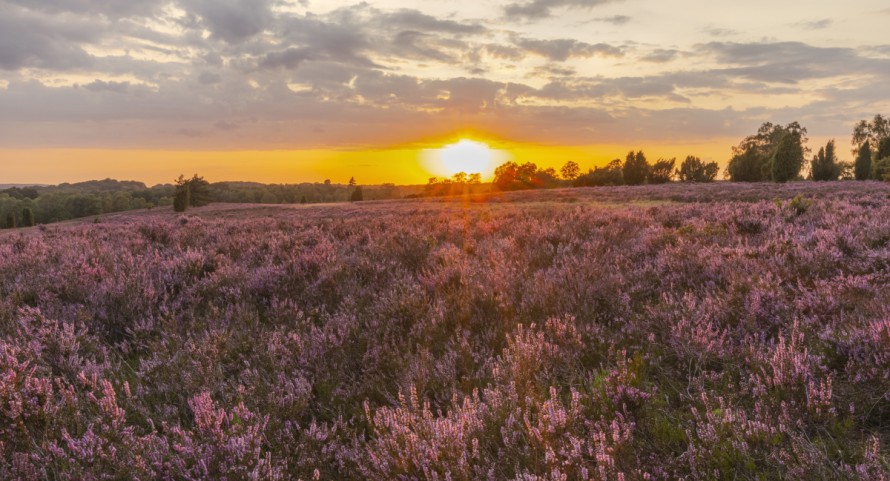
[726,122,807,182]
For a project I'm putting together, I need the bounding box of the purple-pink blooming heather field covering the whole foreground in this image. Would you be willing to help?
[0,182,890,481]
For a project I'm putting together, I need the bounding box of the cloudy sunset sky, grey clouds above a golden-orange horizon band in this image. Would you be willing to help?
[0,0,890,184]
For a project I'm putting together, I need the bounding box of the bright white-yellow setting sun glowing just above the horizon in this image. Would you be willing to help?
[421,139,508,178]
